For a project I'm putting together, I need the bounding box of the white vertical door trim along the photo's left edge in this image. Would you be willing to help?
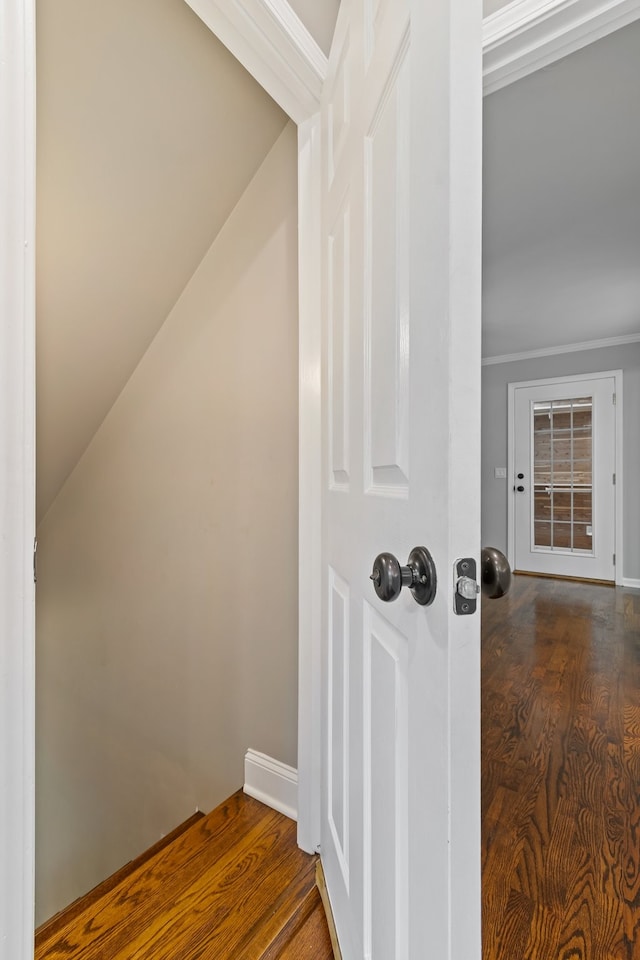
[0,0,35,960]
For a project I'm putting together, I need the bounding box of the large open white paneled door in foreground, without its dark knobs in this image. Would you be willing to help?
[321,0,481,960]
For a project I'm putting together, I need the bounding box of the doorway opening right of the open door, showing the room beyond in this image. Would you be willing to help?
[482,15,640,960]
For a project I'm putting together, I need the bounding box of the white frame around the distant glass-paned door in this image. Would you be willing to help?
[507,370,624,586]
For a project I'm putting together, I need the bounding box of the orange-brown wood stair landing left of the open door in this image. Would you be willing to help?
[35,791,333,960]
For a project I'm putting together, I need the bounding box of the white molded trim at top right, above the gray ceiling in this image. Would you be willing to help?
[482,0,640,95]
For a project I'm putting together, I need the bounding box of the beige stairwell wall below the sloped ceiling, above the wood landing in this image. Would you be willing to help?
[37,124,298,922]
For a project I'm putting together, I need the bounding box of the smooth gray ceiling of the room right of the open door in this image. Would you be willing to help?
[483,22,640,357]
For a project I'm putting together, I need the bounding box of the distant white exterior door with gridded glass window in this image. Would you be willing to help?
[511,373,617,580]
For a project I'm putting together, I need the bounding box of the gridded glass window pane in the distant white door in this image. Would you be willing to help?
[533,397,594,553]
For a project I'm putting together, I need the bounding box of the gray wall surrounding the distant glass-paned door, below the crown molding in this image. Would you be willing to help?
[482,343,640,580]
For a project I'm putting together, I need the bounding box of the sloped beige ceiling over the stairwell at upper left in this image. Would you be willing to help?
[36,0,287,522]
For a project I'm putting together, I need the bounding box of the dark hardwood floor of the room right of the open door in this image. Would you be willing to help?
[482,576,640,960]
